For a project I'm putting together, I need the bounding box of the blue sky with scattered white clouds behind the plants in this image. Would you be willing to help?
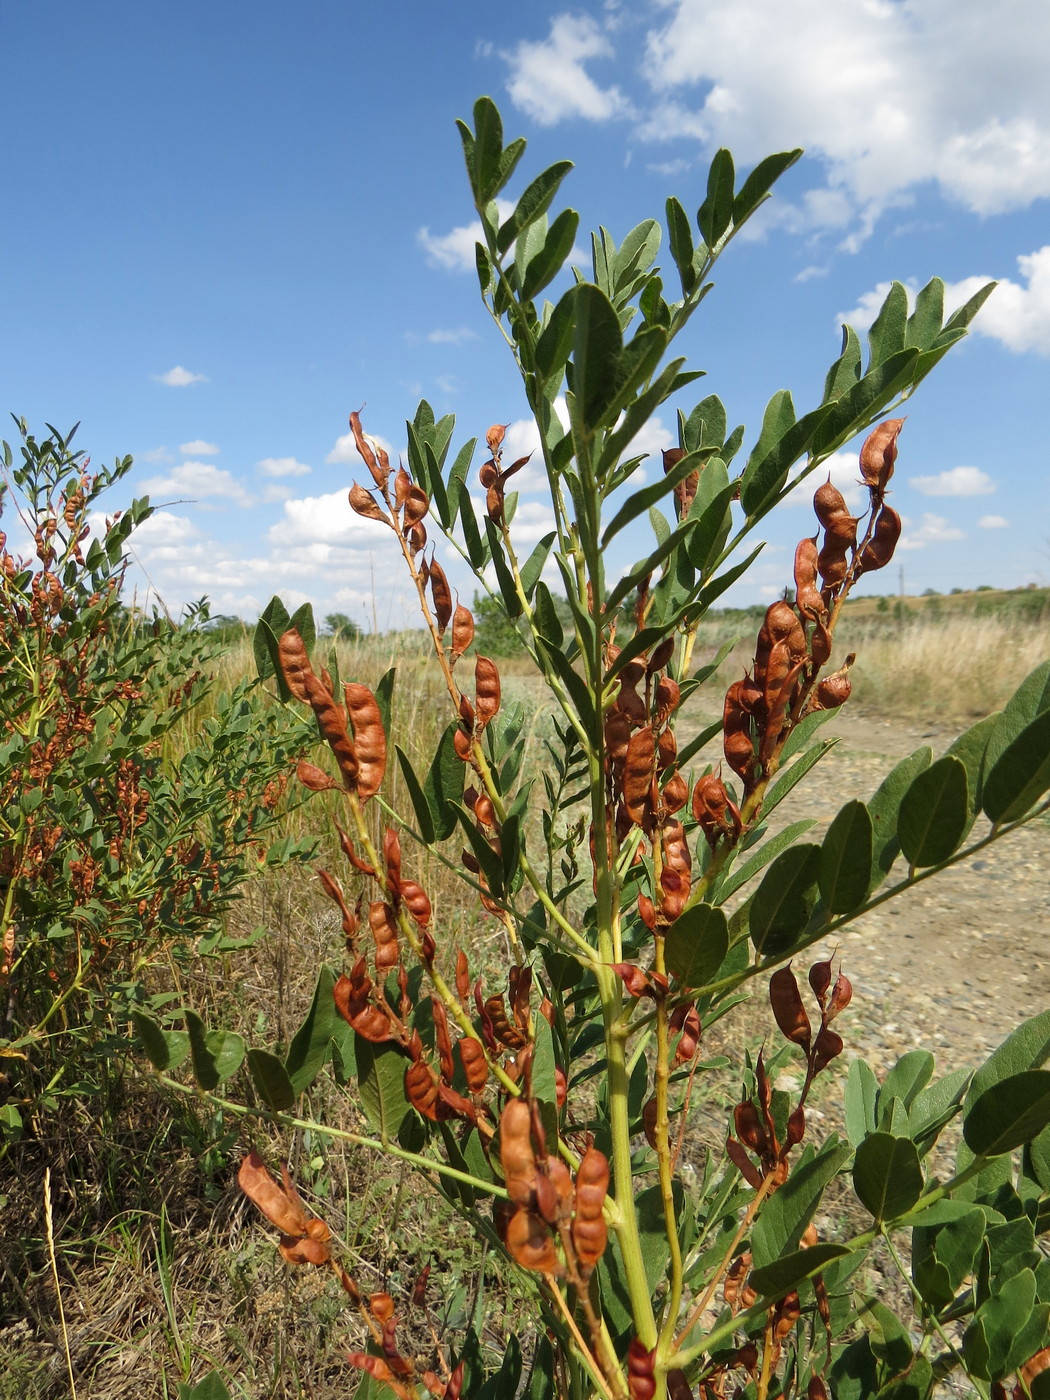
[0,0,1050,627]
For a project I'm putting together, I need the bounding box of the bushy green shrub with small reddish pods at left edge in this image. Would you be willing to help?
[0,423,315,1124]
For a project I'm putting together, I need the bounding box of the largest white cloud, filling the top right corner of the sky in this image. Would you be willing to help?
[638,0,1050,238]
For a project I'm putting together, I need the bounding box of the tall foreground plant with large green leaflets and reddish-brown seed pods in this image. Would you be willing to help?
[139,98,1050,1400]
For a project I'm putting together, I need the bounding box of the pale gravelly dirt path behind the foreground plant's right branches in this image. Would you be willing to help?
[750,711,1050,1072]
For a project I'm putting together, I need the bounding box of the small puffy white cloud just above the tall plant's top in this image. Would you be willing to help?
[503,14,631,126]
